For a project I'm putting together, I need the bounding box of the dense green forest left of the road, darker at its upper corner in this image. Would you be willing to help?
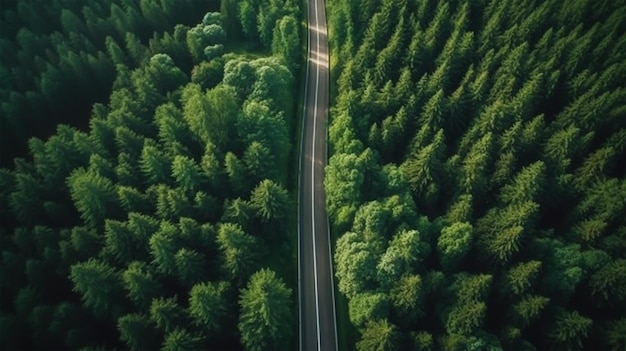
[0,0,302,350]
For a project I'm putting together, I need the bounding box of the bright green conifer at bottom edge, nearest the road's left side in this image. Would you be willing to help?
[238,269,293,350]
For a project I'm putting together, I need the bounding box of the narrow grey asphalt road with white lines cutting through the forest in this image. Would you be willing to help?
[298,0,337,351]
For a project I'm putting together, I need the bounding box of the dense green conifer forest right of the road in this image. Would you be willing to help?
[325,0,626,351]
